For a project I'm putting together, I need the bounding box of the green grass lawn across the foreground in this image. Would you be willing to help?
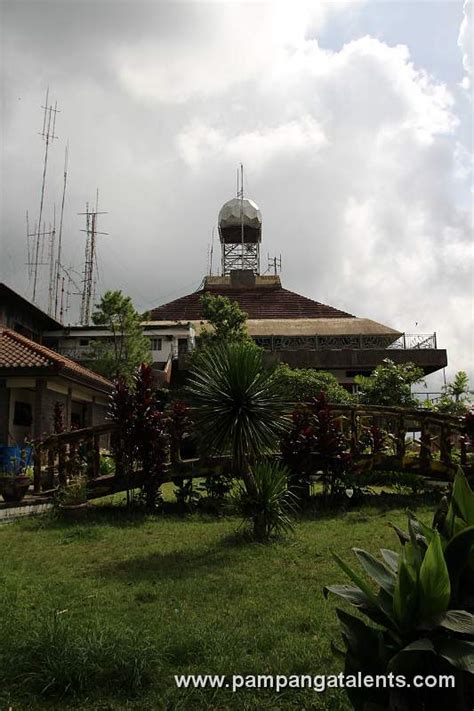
[0,507,431,711]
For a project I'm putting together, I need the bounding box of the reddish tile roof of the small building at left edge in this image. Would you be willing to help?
[0,327,113,390]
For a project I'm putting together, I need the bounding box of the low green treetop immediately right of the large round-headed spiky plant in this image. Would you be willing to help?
[275,363,354,403]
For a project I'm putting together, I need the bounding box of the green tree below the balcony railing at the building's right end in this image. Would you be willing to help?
[354,358,423,407]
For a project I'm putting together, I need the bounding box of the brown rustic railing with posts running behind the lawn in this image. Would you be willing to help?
[33,404,472,496]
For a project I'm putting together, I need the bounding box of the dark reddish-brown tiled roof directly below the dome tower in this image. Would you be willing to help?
[149,286,354,321]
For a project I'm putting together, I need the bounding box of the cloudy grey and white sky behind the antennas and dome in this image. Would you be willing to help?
[0,0,474,389]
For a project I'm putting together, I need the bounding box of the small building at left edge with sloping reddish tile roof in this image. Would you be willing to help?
[0,325,113,445]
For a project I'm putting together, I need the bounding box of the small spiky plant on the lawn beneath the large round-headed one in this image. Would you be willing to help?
[234,461,296,542]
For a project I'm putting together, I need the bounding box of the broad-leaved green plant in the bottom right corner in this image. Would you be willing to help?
[325,472,474,711]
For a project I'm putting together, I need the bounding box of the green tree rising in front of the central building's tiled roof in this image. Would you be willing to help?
[199,292,253,348]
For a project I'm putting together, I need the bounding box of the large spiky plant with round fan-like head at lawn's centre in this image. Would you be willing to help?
[187,342,289,483]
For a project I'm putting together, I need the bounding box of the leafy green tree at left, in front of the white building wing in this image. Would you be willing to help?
[91,291,151,382]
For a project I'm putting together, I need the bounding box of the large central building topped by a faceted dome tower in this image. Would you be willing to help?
[150,195,447,389]
